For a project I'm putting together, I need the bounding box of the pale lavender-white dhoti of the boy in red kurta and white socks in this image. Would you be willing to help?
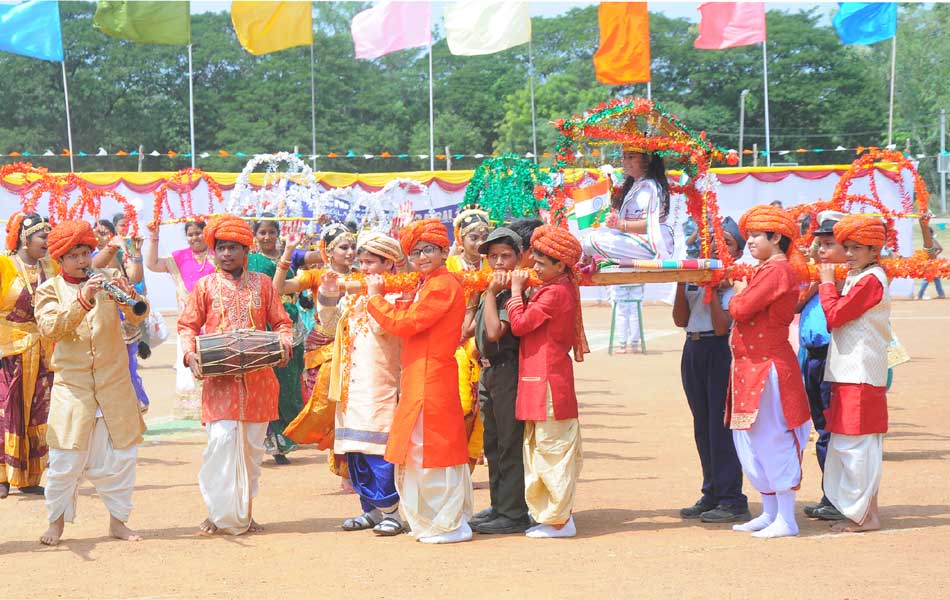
[732,366,811,494]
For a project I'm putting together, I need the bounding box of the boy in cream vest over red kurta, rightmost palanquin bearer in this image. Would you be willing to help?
[818,215,891,531]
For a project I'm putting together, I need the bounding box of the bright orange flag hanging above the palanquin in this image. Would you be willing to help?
[594,2,650,85]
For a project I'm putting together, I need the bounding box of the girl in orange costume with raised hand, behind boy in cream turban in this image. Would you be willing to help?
[274,223,356,478]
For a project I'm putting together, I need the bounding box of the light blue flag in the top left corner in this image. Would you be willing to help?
[0,0,63,62]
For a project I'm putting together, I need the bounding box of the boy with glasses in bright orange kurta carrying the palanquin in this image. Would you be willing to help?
[366,219,474,544]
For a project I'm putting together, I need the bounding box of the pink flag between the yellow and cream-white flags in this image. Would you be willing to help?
[350,0,432,58]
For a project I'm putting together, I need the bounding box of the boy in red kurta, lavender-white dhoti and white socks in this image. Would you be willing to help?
[726,205,811,538]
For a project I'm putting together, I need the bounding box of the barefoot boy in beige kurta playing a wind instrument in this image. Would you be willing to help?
[35,221,148,546]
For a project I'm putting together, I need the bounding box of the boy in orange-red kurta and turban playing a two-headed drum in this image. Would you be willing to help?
[178,215,293,535]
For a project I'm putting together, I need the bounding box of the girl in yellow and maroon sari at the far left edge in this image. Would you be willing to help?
[0,212,58,498]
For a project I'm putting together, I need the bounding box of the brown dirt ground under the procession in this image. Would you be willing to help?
[0,301,950,599]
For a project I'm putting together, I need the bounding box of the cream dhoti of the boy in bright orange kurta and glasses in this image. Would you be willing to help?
[396,412,475,539]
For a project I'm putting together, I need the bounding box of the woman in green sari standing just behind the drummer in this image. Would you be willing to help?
[247,213,319,465]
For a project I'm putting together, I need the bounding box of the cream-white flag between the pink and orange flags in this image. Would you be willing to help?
[445,0,531,56]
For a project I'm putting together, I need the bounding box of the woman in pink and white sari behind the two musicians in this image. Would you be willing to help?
[145,221,214,420]
